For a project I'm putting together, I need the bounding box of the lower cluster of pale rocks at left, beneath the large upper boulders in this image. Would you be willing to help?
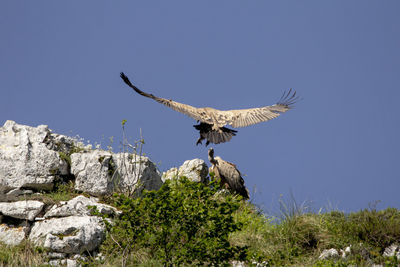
[0,195,115,264]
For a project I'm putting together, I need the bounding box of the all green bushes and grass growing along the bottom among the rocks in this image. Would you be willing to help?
[0,175,400,266]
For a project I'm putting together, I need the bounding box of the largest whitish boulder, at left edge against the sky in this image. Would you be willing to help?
[0,120,68,193]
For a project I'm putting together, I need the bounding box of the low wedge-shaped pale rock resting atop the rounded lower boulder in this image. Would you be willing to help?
[44,196,118,218]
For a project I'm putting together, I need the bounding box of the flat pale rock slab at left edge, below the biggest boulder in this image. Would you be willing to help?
[0,200,44,221]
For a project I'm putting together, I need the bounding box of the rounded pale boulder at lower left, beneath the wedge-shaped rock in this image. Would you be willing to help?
[29,216,105,254]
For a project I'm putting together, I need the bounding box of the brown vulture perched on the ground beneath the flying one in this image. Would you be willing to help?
[208,148,249,199]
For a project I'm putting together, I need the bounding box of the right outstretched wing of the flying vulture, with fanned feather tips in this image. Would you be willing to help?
[220,89,298,127]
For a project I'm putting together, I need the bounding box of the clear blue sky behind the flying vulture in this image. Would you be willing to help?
[0,0,400,212]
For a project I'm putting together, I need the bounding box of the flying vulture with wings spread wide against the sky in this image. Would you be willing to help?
[121,72,298,146]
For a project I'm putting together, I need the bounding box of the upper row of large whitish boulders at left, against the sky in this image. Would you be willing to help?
[0,121,162,197]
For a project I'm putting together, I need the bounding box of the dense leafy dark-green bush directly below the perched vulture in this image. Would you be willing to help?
[103,178,246,266]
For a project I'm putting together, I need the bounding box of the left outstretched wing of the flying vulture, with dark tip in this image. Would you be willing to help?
[120,72,205,122]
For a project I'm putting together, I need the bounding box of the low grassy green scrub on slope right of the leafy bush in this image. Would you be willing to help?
[231,204,400,266]
